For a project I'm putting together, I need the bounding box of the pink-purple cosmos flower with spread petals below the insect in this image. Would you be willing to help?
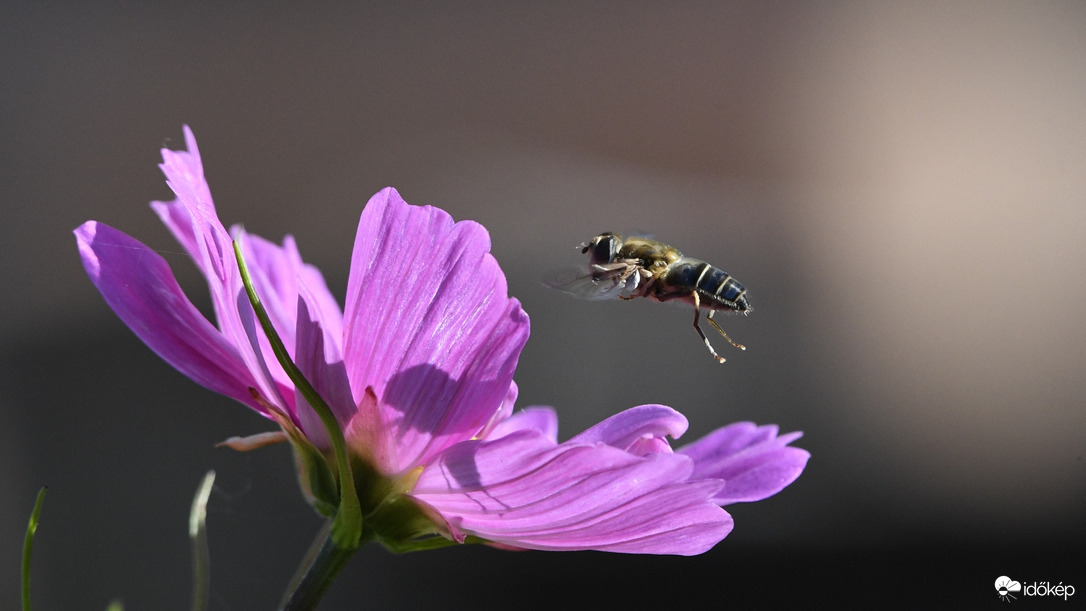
[75,127,809,555]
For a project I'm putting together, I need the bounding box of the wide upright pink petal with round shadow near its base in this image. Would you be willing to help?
[343,188,528,470]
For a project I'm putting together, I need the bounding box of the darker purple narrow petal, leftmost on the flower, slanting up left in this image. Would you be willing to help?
[75,220,267,415]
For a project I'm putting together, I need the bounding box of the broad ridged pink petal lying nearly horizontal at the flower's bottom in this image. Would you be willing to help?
[411,430,732,556]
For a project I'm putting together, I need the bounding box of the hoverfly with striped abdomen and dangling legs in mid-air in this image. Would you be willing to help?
[547,231,752,362]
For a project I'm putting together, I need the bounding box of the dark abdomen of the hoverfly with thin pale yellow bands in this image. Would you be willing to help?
[653,257,752,311]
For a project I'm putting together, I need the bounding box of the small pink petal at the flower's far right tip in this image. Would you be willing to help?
[675,422,810,506]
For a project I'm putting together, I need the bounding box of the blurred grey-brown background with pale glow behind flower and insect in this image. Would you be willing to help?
[0,1,1086,610]
